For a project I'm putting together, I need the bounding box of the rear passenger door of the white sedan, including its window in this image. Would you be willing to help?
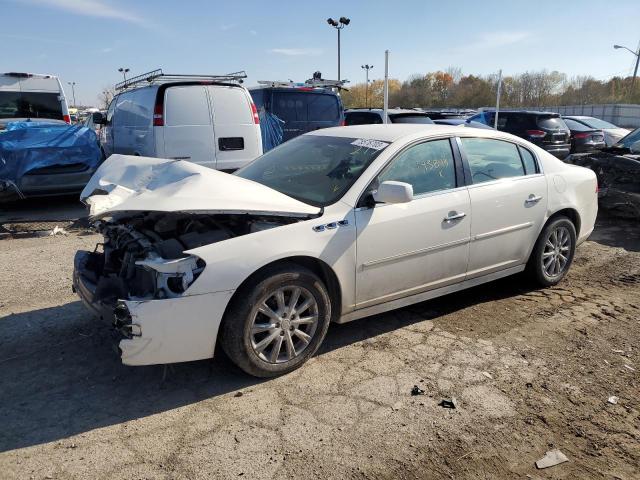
[460,138,547,278]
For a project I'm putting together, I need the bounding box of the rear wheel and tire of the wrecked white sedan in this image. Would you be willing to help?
[527,216,576,287]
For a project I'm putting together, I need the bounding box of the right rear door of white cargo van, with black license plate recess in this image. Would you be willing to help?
[207,85,262,170]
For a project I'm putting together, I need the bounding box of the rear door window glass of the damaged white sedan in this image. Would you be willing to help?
[461,138,525,184]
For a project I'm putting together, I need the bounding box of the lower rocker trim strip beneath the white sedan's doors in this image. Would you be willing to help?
[336,265,525,323]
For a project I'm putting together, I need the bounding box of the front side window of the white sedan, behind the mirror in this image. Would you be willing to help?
[378,139,456,195]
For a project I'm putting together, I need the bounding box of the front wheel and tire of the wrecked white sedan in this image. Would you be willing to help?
[220,264,331,378]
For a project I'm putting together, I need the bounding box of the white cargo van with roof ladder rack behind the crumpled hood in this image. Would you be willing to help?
[94,70,262,170]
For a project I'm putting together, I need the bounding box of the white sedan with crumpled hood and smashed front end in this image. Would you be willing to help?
[74,125,597,377]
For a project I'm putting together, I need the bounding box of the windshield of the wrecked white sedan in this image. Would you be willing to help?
[234,135,389,207]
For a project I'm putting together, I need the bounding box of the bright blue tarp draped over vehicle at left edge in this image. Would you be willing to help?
[0,122,102,197]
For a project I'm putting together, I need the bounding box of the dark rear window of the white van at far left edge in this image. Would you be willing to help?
[0,92,63,120]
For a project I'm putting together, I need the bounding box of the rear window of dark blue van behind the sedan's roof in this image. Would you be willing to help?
[272,92,340,122]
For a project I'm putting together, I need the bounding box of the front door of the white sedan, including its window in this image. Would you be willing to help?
[355,139,471,308]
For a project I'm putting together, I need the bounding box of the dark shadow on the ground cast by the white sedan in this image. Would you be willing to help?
[0,274,528,451]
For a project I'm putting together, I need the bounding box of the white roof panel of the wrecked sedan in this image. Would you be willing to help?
[307,123,496,142]
